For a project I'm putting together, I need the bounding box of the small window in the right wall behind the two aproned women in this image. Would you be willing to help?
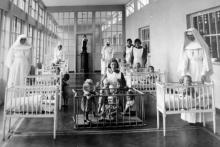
[139,26,150,52]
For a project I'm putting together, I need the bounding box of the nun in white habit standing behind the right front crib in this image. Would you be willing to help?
[178,28,213,123]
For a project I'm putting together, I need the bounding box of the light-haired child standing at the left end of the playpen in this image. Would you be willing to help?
[81,79,96,123]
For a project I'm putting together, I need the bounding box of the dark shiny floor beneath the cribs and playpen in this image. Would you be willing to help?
[0,74,220,147]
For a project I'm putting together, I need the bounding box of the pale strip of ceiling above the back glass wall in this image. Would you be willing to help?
[42,0,130,7]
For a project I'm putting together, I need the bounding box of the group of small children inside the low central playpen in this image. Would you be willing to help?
[81,78,135,123]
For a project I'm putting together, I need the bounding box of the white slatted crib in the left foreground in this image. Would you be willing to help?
[3,86,58,140]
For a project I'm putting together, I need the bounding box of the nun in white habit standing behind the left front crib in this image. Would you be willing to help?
[5,34,31,87]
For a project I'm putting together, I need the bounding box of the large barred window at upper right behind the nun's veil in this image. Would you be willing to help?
[190,7,220,62]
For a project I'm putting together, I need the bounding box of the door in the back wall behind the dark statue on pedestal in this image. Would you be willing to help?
[76,33,93,72]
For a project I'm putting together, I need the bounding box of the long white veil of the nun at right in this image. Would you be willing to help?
[177,28,213,77]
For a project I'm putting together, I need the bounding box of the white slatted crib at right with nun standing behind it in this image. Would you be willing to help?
[156,82,216,136]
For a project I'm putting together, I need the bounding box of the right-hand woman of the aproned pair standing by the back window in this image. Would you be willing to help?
[132,39,147,67]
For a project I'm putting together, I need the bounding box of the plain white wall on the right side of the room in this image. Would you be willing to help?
[126,0,220,108]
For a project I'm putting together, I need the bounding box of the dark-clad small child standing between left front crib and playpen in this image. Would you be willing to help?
[62,74,70,107]
